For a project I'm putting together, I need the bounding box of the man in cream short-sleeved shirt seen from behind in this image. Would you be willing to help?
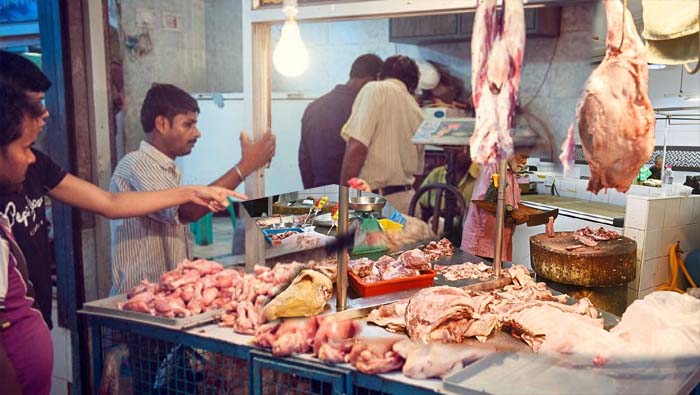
[340,55,424,213]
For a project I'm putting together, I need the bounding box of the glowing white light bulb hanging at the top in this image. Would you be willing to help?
[272,0,309,77]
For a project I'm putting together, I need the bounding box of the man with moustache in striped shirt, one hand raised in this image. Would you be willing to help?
[110,84,275,294]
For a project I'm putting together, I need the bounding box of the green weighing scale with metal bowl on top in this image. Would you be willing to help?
[349,196,389,259]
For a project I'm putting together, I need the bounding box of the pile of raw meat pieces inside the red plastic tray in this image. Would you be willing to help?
[348,249,432,284]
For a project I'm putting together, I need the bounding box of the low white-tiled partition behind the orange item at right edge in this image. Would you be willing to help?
[624,196,700,301]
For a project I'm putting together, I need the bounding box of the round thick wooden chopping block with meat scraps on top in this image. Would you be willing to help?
[530,232,637,287]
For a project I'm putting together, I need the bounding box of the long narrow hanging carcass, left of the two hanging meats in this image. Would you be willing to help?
[470,0,525,164]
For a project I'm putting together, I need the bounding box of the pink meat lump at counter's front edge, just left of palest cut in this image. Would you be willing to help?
[348,337,404,374]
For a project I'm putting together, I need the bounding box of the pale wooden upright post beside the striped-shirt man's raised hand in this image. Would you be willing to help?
[241,0,272,271]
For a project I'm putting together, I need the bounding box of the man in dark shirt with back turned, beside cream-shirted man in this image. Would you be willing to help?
[299,54,382,189]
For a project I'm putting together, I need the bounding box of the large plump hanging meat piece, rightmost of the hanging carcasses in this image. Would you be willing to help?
[572,0,655,193]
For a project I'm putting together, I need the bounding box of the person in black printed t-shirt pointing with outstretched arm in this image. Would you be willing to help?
[0,51,244,328]
